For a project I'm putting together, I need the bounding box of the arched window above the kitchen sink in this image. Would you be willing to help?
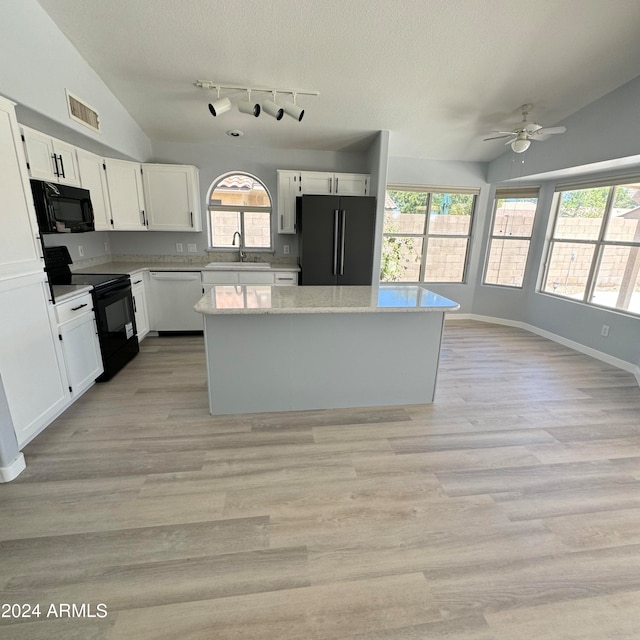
[209,171,273,251]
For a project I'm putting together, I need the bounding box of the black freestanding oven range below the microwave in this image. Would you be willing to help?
[44,247,140,382]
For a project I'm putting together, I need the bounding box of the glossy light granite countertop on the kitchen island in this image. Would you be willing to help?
[195,285,460,315]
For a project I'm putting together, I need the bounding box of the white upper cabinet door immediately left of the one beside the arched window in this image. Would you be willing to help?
[104,158,147,231]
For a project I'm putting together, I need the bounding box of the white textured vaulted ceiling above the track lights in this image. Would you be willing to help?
[39,0,640,161]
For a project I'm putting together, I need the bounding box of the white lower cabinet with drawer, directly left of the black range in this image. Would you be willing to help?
[56,293,104,398]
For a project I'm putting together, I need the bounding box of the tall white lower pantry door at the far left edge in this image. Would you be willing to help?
[0,273,69,448]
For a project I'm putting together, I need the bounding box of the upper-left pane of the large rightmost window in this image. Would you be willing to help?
[554,187,611,240]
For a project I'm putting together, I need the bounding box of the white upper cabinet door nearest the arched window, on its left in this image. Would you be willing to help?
[142,164,202,231]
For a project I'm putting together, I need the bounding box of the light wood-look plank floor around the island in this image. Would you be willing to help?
[0,321,640,640]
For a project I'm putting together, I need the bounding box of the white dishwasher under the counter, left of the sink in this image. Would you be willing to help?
[149,271,204,331]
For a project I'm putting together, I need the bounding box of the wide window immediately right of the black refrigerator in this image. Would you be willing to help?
[380,185,479,283]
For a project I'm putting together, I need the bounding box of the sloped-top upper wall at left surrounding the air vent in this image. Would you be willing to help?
[0,0,151,160]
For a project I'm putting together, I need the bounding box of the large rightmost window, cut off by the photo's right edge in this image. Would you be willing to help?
[542,178,640,315]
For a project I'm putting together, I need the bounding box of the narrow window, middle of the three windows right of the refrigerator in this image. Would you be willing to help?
[483,188,538,288]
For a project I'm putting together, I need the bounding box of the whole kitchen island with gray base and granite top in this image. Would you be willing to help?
[195,285,459,415]
